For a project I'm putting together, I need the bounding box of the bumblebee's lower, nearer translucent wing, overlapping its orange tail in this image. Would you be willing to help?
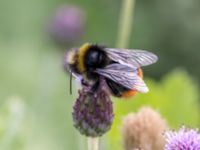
[95,63,149,93]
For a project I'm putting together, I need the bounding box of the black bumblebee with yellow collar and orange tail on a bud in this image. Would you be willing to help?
[65,43,158,97]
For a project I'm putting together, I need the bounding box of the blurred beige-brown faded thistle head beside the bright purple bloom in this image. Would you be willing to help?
[122,107,167,150]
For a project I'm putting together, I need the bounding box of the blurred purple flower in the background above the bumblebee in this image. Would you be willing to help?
[48,5,85,46]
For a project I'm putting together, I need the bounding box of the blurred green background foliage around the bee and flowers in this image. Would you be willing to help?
[0,0,200,150]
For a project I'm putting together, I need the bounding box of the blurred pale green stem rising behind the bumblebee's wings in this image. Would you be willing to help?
[116,0,135,48]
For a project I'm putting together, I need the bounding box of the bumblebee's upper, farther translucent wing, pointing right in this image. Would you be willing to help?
[105,48,158,68]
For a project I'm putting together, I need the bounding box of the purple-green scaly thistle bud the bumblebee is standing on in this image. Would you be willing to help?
[72,81,114,137]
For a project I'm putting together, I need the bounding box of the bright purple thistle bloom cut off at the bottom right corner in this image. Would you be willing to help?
[165,127,200,150]
